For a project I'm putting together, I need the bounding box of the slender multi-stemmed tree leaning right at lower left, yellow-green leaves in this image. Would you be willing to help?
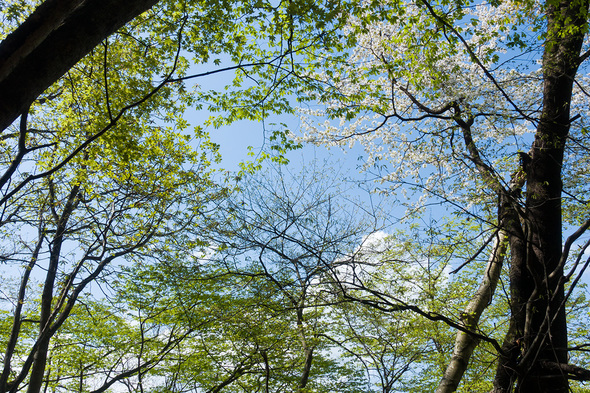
[2,104,223,391]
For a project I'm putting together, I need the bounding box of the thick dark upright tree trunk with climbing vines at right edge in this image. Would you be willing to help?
[495,0,588,393]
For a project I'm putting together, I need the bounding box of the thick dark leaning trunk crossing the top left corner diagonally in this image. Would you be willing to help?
[0,0,158,131]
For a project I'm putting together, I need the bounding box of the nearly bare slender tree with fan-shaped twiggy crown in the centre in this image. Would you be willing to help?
[205,162,372,392]
